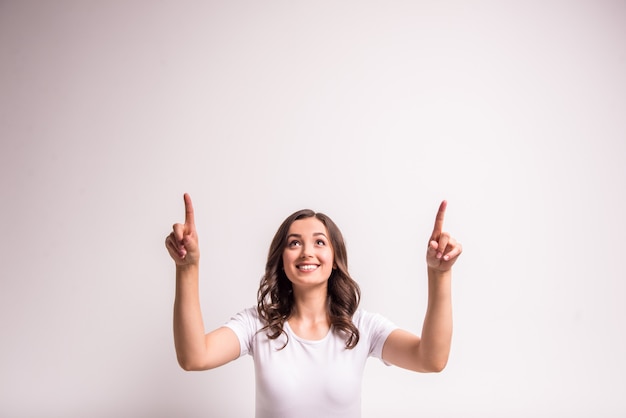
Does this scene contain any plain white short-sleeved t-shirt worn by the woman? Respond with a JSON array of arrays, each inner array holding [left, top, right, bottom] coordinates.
[[225, 308, 396, 418]]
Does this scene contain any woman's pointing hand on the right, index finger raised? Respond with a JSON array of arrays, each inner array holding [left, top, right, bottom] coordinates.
[[426, 200, 463, 272]]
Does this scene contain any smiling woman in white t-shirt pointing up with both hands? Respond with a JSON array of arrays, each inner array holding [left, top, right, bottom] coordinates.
[[166, 194, 462, 418]]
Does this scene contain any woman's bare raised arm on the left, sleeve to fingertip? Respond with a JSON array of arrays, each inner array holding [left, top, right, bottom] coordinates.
[[165, 194, 239, 370]]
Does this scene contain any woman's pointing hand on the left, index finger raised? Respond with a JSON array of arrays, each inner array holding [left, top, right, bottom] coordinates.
[[165, 193, 200, 266]]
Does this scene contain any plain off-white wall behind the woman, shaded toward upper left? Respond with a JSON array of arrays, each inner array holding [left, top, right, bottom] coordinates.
[[0, 0, 626, 417]]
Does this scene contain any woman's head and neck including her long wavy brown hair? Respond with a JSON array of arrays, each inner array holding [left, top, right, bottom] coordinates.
[[258, 209, 361, 348]]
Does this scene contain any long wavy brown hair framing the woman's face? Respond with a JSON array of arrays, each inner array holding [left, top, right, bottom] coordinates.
[[257, 209, 361, 349]]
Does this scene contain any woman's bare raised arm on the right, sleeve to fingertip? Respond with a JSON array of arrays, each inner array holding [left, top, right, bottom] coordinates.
[[383, 200, 462, 372]]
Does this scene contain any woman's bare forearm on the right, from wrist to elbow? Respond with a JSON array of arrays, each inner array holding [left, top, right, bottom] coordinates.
[[419, 268, 452, 371]]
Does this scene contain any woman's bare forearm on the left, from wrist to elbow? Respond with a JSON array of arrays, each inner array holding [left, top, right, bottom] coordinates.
[[174, 264, 206, 370]]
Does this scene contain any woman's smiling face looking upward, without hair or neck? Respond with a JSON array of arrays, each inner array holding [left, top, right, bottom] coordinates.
[[283, 217, 334, 288]]
